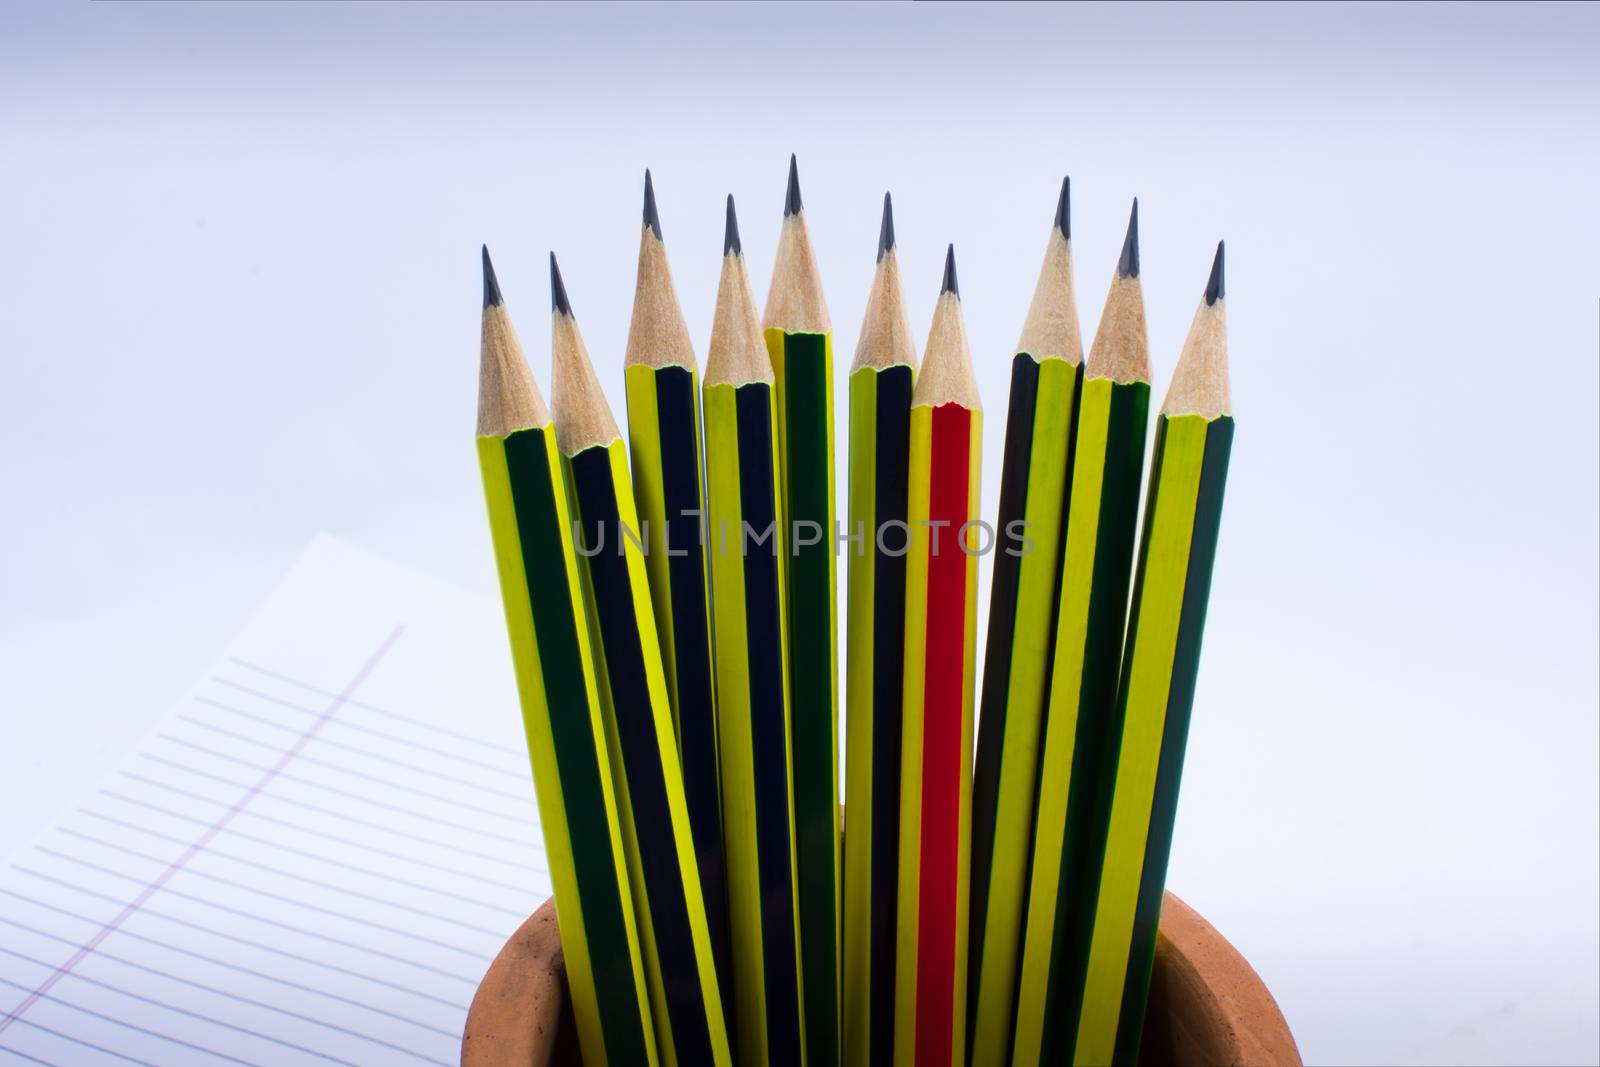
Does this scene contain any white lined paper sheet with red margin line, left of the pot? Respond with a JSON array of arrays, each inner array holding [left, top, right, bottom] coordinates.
[[0, 537, 550, 1065]]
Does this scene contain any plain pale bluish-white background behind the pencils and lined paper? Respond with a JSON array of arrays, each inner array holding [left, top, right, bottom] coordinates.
[[0, 5, 1600, 1062]]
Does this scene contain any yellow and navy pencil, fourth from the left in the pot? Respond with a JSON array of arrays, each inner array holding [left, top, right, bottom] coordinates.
[[704, 197, 805, 1064]]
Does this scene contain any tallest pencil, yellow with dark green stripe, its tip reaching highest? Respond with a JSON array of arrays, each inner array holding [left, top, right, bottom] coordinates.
[[762, 155, 840, 1065]]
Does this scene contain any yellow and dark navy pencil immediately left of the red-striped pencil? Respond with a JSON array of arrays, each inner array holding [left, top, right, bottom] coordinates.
[[843, 194, 917, 1067]]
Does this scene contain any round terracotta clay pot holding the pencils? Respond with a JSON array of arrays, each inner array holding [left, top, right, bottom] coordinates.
[[461, 893, 1301, 1067]]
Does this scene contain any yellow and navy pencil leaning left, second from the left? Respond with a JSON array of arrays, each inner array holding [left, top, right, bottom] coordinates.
[[550, 254, 731, 1064]]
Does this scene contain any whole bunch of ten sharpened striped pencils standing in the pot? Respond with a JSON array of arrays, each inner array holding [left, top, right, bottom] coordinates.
[[478, 168, 1234, 1067]]
